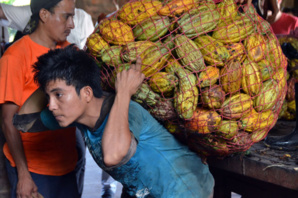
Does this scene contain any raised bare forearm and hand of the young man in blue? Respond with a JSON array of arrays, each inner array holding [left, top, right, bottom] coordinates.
[[102, 58, 145, 166]]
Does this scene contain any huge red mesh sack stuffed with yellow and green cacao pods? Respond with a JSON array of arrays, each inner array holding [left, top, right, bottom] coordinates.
[[87, 0, 287, 156]]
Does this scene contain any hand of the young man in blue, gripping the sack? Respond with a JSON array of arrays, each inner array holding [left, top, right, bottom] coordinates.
[[115, 57, 145, 96]]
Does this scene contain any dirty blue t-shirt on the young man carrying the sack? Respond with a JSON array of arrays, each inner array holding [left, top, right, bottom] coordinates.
[[43, 101, 214, 198]]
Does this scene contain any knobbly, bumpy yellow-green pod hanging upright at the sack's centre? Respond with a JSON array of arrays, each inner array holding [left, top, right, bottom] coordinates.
[[174, 64, 199, 119]]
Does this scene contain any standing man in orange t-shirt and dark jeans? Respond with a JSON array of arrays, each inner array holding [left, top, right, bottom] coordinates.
[[0, 0, 79, 198]]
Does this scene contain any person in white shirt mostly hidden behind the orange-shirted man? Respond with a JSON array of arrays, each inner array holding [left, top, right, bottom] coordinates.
[[0, 1, 117, 198]]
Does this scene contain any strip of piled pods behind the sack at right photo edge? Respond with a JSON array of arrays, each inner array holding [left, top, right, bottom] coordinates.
[[278, 35, 298, 120]]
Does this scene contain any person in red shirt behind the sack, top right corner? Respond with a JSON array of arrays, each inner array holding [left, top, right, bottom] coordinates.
[[258, 0, 298, 35]]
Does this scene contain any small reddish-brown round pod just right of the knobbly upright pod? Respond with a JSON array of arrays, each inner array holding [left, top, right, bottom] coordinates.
[[201, 85, 225, 109]]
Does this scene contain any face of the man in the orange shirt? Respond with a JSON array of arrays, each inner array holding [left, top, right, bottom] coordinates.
[[46, 0, 75, 42]]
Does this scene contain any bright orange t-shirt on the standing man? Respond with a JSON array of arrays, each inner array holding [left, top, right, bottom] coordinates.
[[0, 35, 78, 176]]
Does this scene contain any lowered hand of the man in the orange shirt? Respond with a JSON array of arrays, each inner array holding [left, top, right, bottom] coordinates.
[[16, 175, 40, 198]]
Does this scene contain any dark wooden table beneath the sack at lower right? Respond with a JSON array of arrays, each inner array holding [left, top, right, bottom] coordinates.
[[208, 121, 298, 198]]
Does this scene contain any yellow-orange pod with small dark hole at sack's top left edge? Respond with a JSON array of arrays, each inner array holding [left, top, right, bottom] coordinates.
[[118, 0, 162, 25]]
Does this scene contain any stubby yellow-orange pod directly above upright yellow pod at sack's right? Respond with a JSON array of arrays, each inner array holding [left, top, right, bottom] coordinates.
[[244, 33, 266, 62]]
